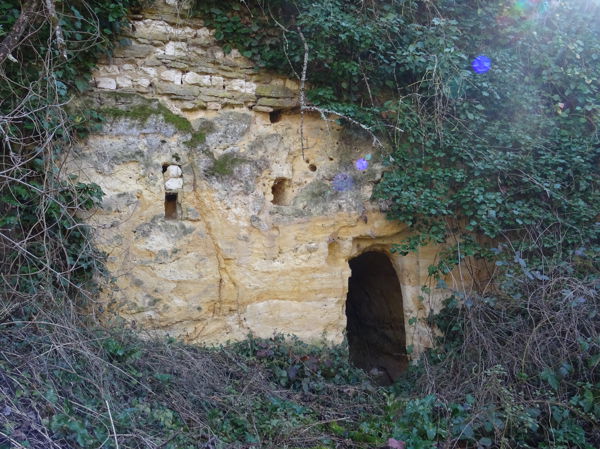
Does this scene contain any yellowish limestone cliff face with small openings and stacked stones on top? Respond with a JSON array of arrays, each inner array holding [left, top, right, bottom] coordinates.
[[69, 1, 448, 353]]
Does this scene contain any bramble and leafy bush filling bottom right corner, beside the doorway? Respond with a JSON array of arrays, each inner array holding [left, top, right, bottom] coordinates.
[[395, 250, 600, 449]]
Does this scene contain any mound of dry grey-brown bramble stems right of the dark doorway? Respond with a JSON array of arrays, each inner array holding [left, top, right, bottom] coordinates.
[[419, 252, 600, 447]]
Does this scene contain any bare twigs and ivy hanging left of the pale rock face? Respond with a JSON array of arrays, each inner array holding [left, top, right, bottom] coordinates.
[[0, 0, 142, 319]]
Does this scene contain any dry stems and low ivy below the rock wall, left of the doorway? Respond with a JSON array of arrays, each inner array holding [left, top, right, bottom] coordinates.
[[0, 321, 386, 449]]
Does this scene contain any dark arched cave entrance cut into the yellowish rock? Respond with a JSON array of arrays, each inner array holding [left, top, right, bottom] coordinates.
[[346, 251, 408, 384]]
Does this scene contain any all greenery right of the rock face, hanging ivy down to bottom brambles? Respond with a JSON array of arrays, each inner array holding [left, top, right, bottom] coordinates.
[[197, 0, 600, 448]]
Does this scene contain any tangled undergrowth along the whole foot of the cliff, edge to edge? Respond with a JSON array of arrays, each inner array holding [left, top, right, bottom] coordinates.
[[0, 256, 600, 449]]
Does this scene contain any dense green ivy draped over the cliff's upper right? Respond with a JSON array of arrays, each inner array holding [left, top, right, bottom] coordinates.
[[197, 0, 600, 268]]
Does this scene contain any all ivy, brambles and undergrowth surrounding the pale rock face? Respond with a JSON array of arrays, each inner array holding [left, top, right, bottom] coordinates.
[[0, 0, 600, 449]]
